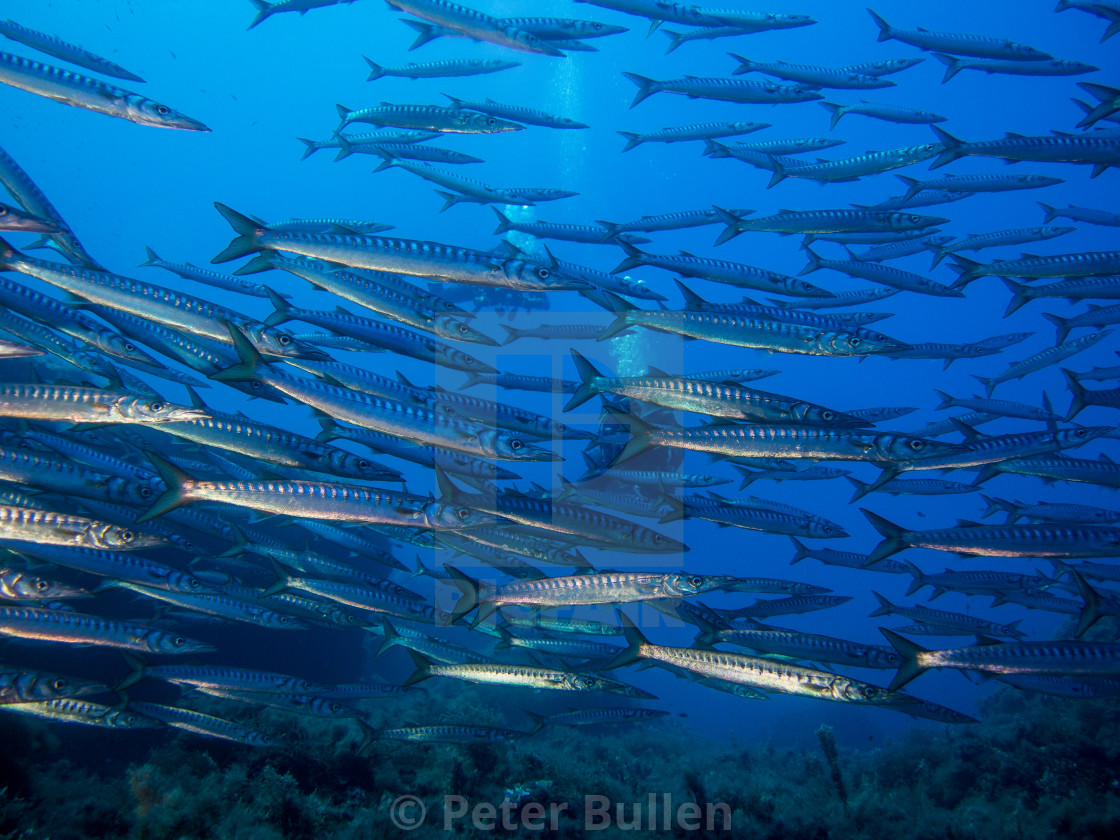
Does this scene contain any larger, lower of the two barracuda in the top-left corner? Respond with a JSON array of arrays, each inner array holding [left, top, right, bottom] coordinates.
[[0, 53, 209, 131]]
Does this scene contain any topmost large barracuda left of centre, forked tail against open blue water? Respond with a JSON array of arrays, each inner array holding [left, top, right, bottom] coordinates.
[[212, 203, 587, 291]]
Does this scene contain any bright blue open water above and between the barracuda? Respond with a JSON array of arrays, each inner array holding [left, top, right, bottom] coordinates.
[[0, 0, 1120, 801]]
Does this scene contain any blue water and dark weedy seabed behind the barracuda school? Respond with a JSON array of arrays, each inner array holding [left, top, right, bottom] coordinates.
[[0, 0, 1120, 839]]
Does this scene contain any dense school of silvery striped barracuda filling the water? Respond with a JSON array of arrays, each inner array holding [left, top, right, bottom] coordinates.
[[0, 0, 1120, 747]]
